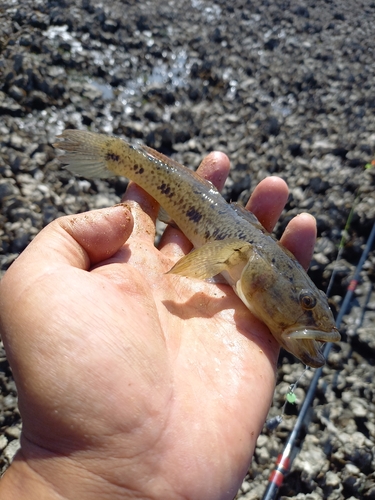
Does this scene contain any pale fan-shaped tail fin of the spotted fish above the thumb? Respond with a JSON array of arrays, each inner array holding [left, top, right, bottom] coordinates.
[[53, 130, 123, 179]]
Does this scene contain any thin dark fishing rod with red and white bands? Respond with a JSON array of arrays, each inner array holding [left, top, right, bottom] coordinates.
[[262, 222, 375, 500]]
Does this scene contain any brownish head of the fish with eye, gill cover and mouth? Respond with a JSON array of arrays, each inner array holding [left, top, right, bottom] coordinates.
[[236, 247, 340, 368]]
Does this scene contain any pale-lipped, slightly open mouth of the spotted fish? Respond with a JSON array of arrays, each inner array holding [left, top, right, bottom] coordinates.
[[282, 327, 341, 368]]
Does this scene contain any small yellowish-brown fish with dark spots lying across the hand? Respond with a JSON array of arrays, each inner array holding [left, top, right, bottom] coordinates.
[[54, 129, 340, 368]]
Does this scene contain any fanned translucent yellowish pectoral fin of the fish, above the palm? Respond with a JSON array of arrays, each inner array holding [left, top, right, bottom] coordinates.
[[168, 239, 252, 279]]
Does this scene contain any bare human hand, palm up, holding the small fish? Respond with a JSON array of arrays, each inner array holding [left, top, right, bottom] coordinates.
[[0, 153, 316, 500]]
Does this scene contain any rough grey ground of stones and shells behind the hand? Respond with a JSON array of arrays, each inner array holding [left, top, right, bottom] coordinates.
[[0, 0, 375, 500]]
